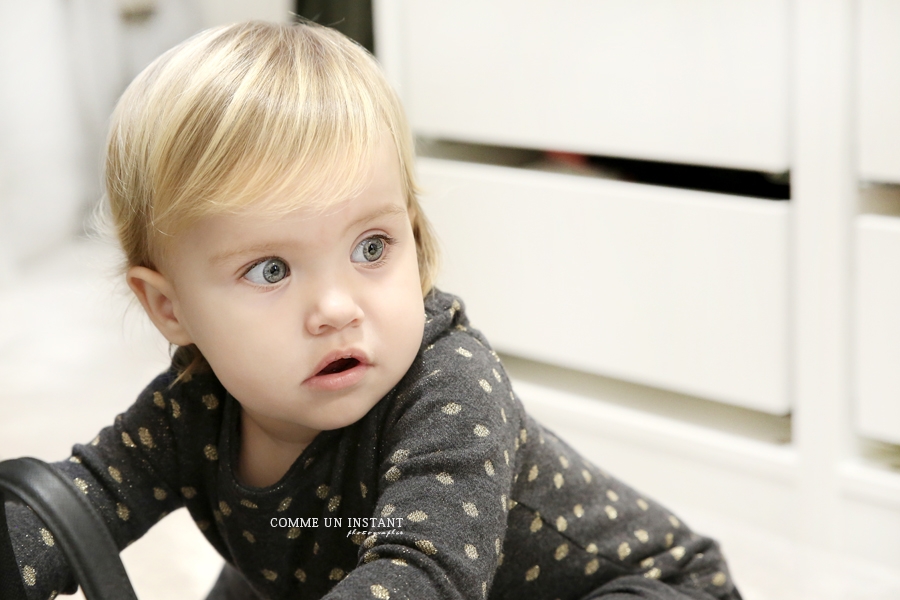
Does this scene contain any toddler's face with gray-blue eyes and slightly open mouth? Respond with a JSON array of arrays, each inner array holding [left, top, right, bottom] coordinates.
[[164, 139, 424, 442]]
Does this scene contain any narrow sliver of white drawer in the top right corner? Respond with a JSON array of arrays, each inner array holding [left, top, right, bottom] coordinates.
[[857, 0, 900, 182]]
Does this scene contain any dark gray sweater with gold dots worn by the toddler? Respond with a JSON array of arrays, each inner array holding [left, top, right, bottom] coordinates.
[[8, 292, 740, 600]]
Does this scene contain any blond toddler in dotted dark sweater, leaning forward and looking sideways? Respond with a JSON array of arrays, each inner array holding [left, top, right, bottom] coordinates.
[[8, 23, 740, 600]]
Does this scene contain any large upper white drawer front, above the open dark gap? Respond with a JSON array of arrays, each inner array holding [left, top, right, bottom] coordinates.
[[384, 0, 790, 171]]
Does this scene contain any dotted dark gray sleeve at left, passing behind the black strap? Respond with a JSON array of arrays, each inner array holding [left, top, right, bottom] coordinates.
[[6, 373, 188, 600]]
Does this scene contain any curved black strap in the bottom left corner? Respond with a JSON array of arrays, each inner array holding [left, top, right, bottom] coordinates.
[[0, 458, 137, 600]]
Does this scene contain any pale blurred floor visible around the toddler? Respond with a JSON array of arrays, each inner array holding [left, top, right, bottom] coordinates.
[[0, 239, 900, 600]]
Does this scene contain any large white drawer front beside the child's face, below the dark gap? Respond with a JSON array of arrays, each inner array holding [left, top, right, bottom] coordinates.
[[419, 159, 790, 414]]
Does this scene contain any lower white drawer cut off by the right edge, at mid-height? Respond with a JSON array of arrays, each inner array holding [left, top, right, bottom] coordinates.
[[854, 215, 900, 444]]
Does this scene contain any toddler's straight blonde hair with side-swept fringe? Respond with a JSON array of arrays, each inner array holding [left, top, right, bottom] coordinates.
[[106, 22, 438, 378]]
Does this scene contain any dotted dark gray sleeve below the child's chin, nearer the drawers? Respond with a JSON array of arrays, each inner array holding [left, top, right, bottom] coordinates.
[[326, 332, 519, 600]]
